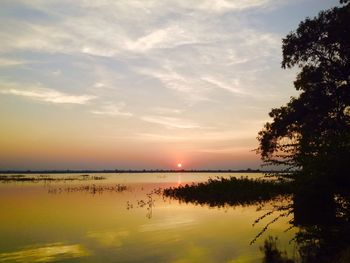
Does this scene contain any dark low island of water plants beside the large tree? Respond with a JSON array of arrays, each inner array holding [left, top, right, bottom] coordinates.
[[163, 177, 292, 206]]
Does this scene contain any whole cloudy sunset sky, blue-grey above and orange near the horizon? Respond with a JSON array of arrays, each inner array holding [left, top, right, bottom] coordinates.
[[0, 0, 338, 170]]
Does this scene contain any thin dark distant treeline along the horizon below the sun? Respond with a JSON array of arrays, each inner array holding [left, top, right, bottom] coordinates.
[[0, 168, 282, 174]]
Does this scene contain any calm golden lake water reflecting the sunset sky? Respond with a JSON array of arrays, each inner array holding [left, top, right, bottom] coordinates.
[[0, 173, 295, 262]]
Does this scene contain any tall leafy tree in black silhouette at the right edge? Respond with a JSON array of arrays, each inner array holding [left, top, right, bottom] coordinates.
[[258, 0, 350, 186]]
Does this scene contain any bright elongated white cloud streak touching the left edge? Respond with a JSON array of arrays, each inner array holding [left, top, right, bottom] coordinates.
[[0, 84, 96, 104]]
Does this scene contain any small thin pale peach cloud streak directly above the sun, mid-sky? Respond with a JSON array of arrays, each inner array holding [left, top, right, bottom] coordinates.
[[141, 116, 201, 129]]
